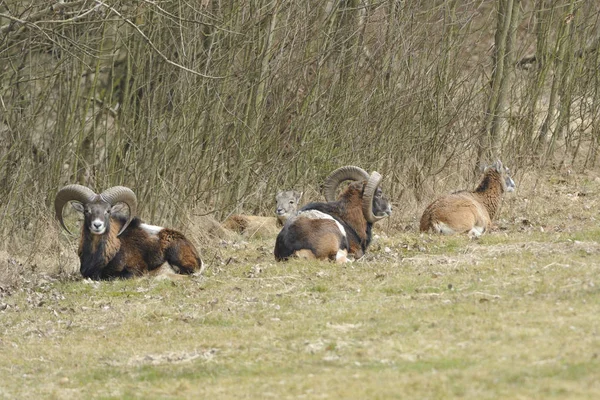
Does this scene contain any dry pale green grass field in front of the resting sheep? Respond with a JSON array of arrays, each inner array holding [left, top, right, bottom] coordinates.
[[0, 170, 600, 399]]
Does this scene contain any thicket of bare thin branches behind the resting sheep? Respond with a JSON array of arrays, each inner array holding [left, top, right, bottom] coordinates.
[[0, 0, 600, 247]]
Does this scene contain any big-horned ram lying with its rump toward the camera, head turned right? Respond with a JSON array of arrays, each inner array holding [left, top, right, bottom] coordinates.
[[274, 166, 392, 262]]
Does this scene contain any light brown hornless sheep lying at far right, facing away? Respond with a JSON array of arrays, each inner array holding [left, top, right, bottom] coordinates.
[[420, 161, 515, 237]]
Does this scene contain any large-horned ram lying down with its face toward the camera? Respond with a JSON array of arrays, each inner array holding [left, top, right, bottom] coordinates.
[[54, 185, 204, 280]]
